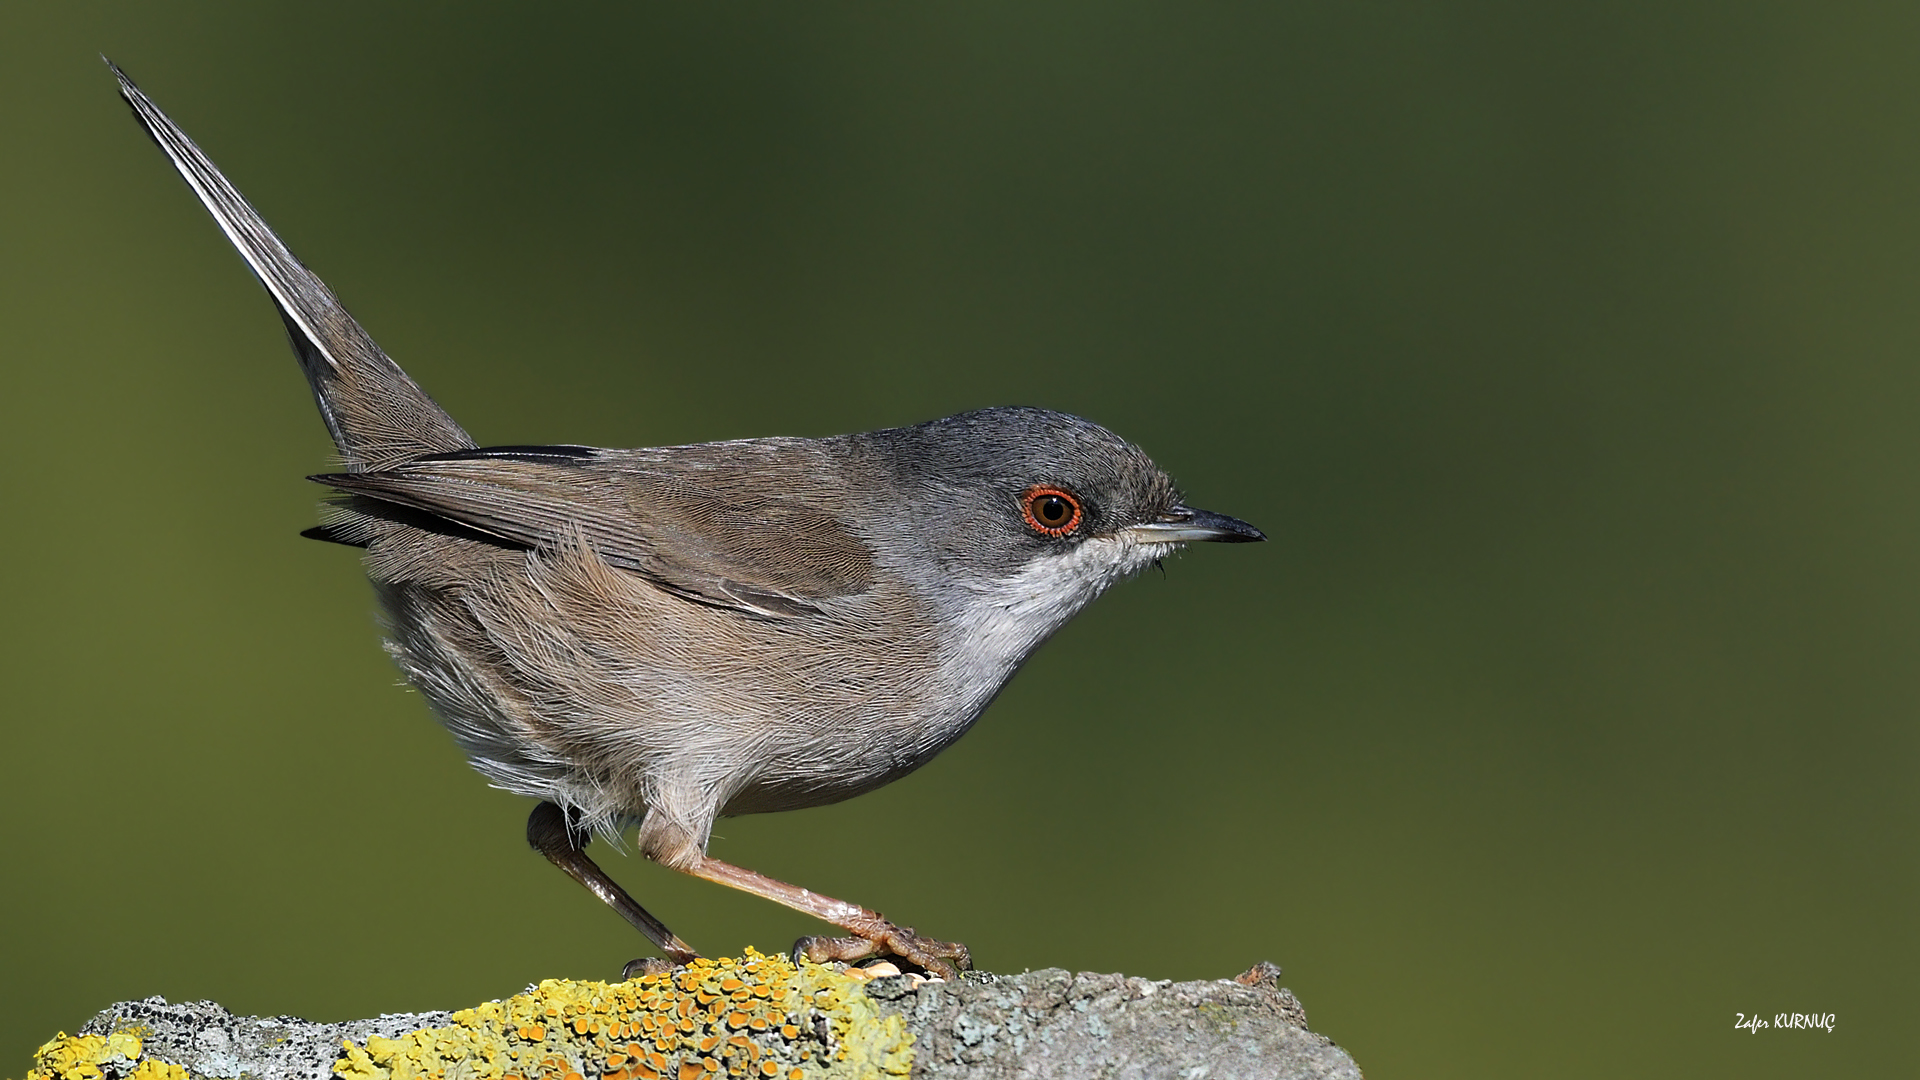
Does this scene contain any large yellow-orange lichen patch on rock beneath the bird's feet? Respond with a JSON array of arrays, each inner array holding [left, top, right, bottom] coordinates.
[[334, 949, 914, 1080]]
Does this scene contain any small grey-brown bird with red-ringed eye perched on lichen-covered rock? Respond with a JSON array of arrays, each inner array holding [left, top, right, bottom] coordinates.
[[108, 61, 1265, 976]]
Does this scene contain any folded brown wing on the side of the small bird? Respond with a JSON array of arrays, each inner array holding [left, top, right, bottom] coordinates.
[[311, 446, 874, 619]]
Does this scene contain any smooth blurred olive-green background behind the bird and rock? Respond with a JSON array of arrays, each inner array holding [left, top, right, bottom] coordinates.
[[0, 0, 1920, 1080]]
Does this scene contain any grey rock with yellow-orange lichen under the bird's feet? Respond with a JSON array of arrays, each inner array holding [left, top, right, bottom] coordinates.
[[29, 949, 1359, 1080]]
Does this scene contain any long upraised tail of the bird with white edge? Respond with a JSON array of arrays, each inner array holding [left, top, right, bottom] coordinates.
[[102, 58, 474, 473]]
